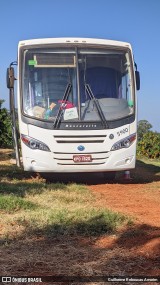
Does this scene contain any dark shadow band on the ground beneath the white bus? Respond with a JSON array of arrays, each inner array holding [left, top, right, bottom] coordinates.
[[0, 160, 160, 185]]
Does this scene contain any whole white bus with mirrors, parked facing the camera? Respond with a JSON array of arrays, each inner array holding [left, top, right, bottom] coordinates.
[[7, 38, 140, 178]]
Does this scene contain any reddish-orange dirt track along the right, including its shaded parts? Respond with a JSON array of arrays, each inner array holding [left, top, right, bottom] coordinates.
[[86, 163, 160, 276]]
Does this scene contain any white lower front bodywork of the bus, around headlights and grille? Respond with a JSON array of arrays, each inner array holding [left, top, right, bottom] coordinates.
[[22, 121, 136, 172]]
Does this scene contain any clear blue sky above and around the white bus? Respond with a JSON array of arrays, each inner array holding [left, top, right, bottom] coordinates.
[[0, 0, 160, 132]]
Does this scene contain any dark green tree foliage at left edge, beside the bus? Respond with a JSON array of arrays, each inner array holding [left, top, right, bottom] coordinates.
[[0, 100, 12, 148]]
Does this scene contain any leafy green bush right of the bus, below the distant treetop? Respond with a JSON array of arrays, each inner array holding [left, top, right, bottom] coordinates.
[[137, 131, 160, 159]]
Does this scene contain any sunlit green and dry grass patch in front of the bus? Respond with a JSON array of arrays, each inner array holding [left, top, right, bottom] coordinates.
[[0, 149, 130, 240]]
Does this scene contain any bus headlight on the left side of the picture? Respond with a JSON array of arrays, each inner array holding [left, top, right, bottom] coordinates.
[[21, 134, 50, 151]]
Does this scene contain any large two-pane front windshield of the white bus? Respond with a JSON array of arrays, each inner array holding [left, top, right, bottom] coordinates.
[[22, 48, 135, 124]]
